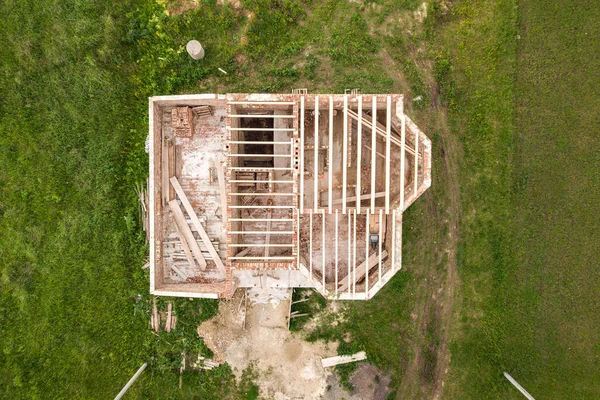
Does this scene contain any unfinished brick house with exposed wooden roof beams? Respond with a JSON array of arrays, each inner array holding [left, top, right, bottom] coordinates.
[[149, 91, 431, 300]]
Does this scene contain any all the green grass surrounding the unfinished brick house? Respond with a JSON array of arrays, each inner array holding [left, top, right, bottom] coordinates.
[[0, 0, 600, 399]]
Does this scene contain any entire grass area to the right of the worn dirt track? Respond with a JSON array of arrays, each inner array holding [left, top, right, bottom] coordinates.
[[445, 0, 600, 399]]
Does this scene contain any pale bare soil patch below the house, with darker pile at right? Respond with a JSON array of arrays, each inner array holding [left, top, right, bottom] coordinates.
[[198, 290, 389, 400]]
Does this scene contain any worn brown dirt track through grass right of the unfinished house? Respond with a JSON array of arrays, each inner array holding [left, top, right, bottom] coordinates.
[[398, 84, 461, 399]]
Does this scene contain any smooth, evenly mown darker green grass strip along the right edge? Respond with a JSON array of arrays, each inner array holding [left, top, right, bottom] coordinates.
[[503, 0, 600, 399]]
